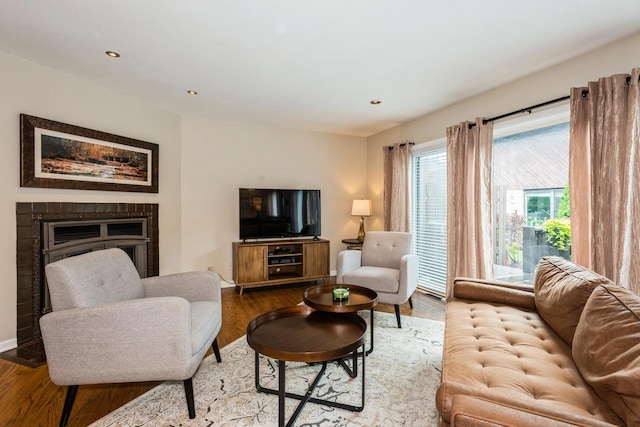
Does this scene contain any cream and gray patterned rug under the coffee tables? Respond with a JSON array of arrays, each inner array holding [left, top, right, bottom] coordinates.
[[91, 311, 444, 427]]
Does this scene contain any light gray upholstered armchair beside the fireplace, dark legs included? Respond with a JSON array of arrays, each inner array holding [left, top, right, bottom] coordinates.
[[40, 249, 222, 426]]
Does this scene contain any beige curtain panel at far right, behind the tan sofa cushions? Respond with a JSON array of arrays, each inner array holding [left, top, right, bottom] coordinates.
[[569, 68, 640, 292]]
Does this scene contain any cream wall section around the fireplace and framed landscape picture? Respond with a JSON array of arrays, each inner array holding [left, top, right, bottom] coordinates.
[[0, 52, 181, 349]]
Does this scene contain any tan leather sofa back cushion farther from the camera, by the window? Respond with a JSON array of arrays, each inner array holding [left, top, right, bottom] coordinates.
[[534, 256, 613, 345]]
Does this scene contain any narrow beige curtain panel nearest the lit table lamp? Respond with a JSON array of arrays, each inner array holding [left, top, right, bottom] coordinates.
[[382, 142, 413, 231]]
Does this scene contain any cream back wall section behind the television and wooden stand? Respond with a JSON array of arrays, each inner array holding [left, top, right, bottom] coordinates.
[[182, 118, 367, 280]]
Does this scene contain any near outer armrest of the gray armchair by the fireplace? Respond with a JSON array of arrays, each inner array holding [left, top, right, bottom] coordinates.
[[40, 297, 192, 385]]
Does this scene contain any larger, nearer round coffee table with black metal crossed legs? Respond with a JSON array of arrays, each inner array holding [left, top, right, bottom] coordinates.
[[247, 305, 367, 426]]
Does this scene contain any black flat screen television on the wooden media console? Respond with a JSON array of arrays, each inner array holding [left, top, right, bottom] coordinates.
[[240, 188, 321, 240]]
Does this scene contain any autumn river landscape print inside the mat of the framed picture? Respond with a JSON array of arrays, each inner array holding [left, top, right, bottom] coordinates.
[[36, 129, 151, 185]]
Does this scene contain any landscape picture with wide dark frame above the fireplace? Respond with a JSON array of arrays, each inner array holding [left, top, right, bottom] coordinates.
[[20, 114, 159, 193]]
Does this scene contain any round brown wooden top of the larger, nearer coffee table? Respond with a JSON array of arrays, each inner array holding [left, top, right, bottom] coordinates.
[[247, 305, 367, 363]]
